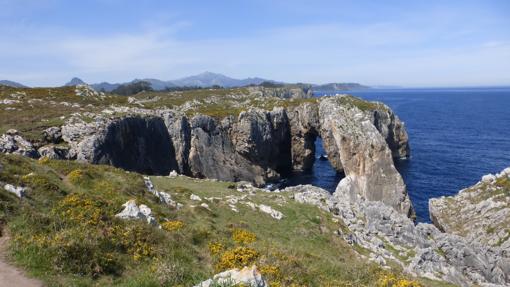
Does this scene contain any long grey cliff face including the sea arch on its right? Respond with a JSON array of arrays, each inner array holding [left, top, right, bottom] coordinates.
[[56, 96, 410, 201]]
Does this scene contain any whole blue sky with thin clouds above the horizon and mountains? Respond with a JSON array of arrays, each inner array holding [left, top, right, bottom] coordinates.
[[0, 0, 510, 87]]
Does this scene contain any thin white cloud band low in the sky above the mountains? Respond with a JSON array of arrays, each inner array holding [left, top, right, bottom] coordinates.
[[0, 18, 510, 85]]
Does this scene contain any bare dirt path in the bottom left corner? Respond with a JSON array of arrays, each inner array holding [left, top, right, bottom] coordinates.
[[0, 230, 43, 287]]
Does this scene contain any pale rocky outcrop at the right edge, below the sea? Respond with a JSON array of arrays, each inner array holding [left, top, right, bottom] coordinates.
[[429, 168, 510, 251]]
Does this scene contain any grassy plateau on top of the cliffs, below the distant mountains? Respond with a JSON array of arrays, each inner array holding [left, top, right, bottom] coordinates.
[[0, 85, 384, 142]]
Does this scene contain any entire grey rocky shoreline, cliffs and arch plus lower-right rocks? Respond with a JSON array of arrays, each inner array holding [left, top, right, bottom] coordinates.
[[0, 84, 510, 286]]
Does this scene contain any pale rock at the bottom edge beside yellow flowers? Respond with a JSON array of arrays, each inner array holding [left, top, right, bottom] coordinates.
[[194, 265, 268, 287]]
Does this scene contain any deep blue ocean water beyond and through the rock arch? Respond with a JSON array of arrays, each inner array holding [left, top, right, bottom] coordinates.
[[291, 88, 510, 222]]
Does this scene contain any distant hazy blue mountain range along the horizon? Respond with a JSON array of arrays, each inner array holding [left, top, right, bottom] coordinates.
[[0, 72, 368, 92]]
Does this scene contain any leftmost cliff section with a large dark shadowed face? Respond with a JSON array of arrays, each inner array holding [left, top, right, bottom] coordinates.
[[62, 116, 178, 175]]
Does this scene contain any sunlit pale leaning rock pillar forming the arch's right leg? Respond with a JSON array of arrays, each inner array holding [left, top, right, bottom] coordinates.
[[319, 97, 414, 216]]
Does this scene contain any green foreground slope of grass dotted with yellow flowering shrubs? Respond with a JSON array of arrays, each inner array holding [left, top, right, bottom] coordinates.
[[0, 155, 452, 286]]
